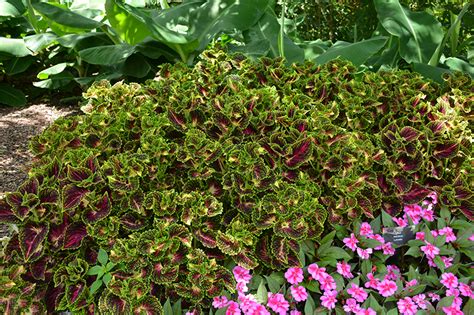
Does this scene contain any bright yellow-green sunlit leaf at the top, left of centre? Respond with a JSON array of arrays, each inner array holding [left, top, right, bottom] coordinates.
[[105, 0, 151, 45]]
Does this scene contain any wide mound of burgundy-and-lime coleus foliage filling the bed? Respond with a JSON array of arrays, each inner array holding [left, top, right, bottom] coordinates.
[[0, 51, 474, 314]]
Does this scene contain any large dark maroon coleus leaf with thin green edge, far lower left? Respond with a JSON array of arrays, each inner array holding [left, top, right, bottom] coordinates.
[[19, 222, 49, 262]]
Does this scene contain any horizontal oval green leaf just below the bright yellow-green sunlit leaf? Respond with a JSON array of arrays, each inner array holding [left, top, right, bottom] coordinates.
[[79, 44, 135, 65]]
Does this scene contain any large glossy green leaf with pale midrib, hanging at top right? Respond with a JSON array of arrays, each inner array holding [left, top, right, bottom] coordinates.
[[374, 0, 443, 63]]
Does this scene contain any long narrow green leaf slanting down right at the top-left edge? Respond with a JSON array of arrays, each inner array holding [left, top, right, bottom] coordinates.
[[33, 2, 102, 30]]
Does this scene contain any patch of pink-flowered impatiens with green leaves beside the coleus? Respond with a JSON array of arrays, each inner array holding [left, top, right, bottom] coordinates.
[[212, 195, 474, 315]]
